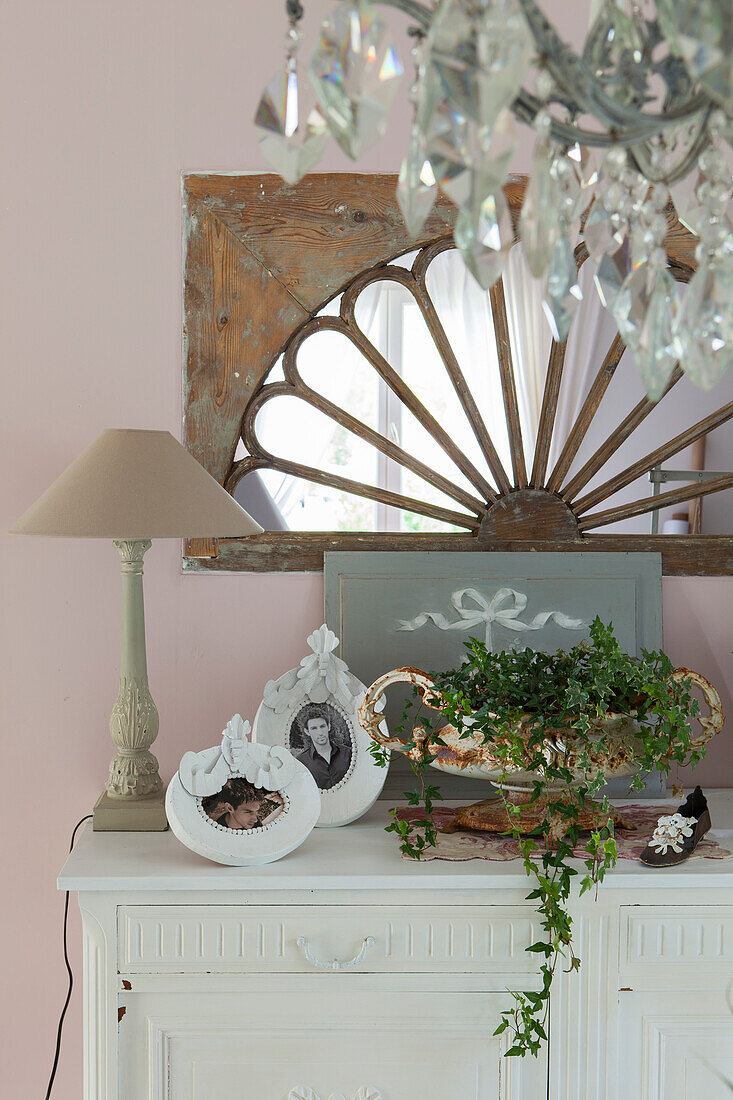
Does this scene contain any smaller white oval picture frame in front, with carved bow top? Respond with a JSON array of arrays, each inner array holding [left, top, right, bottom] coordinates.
[[165, 714, 320, 867]]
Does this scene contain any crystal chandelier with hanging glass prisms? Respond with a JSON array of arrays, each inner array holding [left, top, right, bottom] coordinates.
[[255, 0, 733, 400]]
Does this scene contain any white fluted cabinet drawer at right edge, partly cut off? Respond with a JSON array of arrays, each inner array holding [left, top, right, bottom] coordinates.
[[620, 905, 733, 985]]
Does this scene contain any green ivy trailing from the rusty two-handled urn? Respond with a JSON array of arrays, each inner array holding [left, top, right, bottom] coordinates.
[[372, 617, 704, 1057]]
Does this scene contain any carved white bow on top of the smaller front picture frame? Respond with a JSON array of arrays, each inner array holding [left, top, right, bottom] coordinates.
[[178, 714, 295, 799]]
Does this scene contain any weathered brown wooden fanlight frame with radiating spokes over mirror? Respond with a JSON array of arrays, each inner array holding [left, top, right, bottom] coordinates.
[[185, 174, 733, 574]]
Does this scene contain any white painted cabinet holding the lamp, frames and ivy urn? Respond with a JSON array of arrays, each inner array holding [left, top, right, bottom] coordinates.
[[59, 795, 733, 1100]]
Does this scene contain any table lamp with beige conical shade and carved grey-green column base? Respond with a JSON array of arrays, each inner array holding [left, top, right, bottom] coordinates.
[[11, 428, 262, 832]]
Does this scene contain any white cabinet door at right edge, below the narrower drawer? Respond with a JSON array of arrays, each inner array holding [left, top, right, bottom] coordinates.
[[619, 990, 733, 1100]]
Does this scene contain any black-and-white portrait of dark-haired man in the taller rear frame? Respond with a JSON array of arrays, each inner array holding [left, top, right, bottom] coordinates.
[[288, 703, 353, 791]]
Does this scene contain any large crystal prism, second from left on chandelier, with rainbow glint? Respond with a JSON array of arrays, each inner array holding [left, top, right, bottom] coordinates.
[[310, 0, 402, 160]]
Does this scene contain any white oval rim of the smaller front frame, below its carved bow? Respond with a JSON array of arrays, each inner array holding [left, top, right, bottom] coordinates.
[[165, 719, 320, 867]]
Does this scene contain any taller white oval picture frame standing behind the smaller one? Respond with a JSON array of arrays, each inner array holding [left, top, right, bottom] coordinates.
[[252, 624, 387, 828]]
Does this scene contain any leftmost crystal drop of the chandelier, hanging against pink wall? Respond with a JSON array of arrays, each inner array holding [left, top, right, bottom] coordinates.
[[254, 57, 328, 184]]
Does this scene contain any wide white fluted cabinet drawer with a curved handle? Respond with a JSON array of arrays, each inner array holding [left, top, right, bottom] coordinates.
[[118, 905, 540, 975]]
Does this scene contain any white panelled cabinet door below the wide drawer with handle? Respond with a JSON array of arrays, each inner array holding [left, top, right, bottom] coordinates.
[[120, 979, 547, 1100]]
